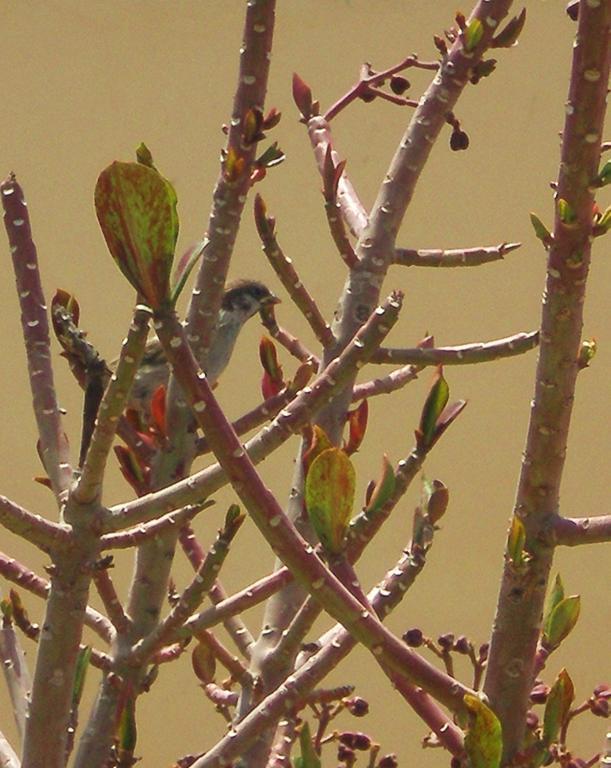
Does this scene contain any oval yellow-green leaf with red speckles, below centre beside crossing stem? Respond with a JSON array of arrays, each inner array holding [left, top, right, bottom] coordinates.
[[305, 448, 355, 554]]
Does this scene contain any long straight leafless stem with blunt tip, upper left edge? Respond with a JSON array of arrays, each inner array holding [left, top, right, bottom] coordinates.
[[0, 174, 72, 504]]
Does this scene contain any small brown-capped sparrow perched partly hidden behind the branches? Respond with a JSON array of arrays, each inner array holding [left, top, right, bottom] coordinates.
[[130, 279, 280, 413]]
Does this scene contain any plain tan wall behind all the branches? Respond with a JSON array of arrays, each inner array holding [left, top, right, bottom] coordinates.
[[0, 0, 611, 766]]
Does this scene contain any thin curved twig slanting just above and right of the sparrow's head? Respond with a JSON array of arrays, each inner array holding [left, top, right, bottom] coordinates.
[[255, 195, 333, 348]]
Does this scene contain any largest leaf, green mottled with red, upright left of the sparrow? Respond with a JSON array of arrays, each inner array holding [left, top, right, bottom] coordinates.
[[95, 162, 178, 309]]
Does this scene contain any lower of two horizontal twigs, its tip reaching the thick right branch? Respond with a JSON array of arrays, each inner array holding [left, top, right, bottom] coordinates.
[[372, 331, 539, 366]]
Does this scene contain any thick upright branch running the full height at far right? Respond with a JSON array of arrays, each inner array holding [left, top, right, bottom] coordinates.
[[484, 2, 611, 762]]
